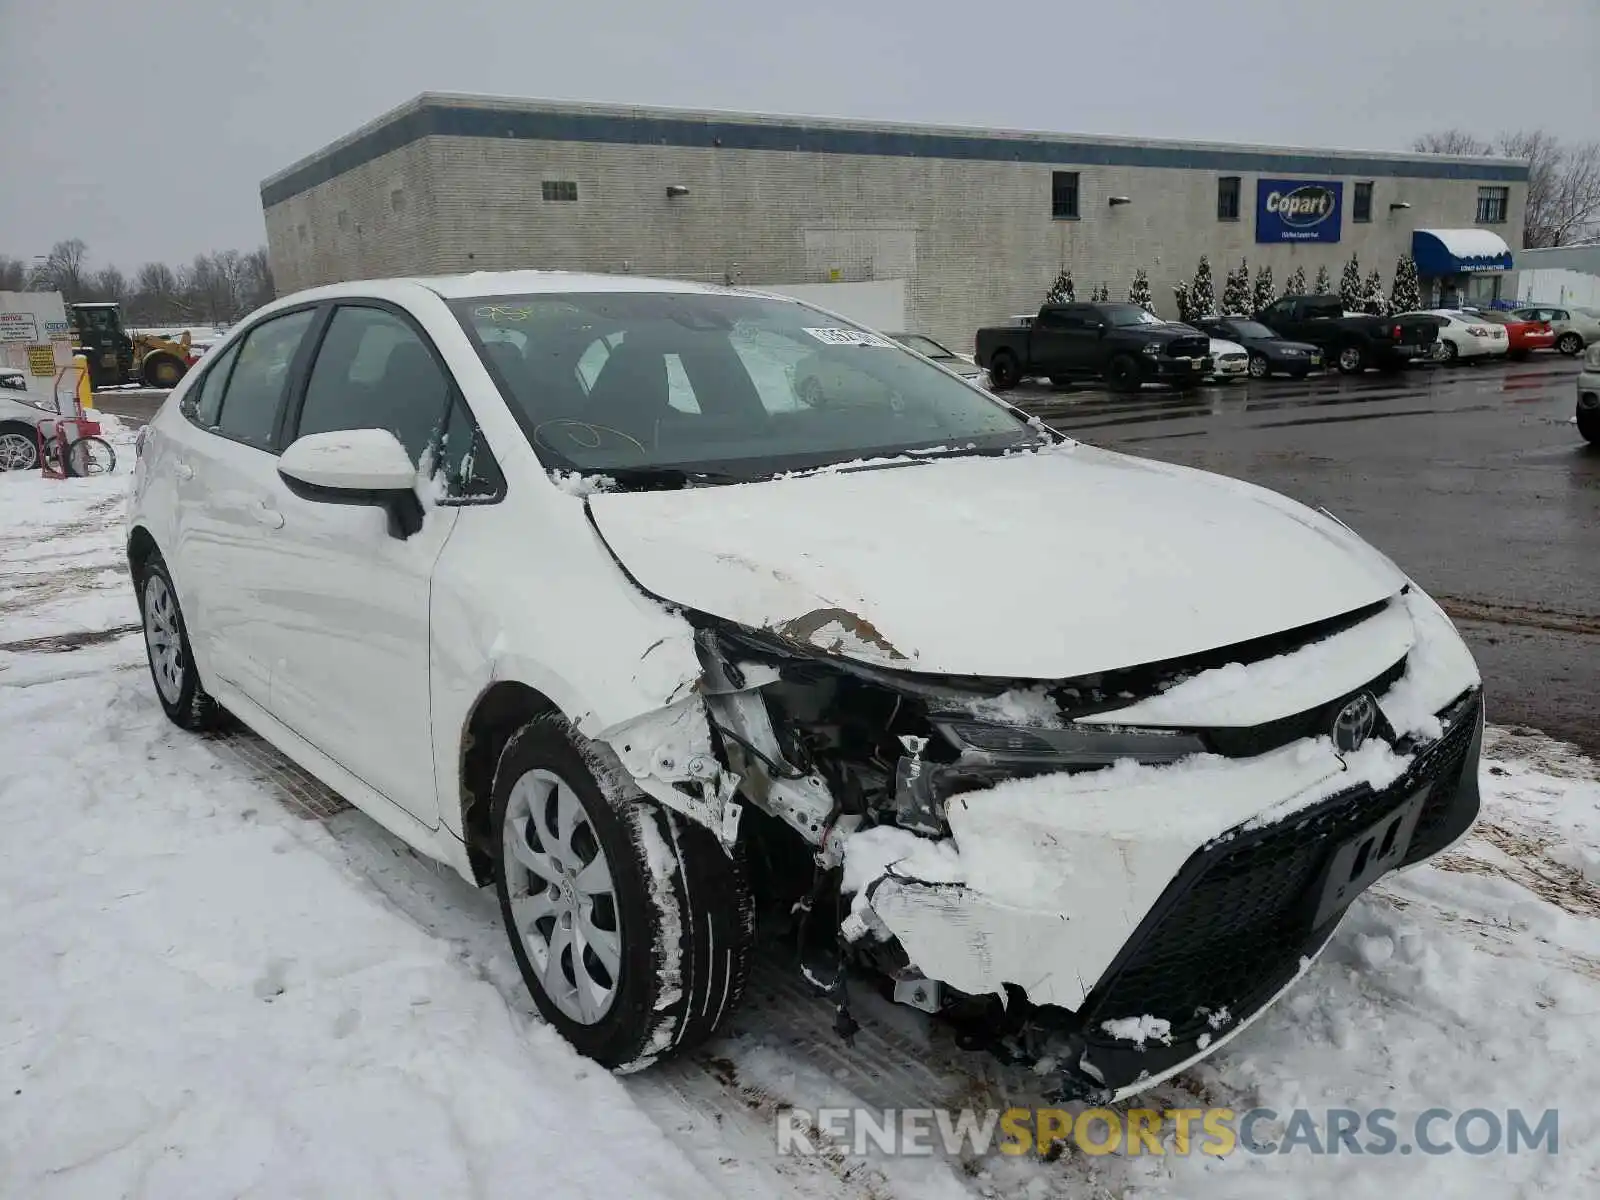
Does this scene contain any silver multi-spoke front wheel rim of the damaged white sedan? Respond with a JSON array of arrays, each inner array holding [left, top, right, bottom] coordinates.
[[501, 770, 622, 1026]]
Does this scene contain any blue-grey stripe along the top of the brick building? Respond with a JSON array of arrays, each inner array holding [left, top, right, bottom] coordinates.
[[261, 106, 1528, 208]]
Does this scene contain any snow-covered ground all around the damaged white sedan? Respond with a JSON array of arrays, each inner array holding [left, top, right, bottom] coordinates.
[[0, 437, 1600, 1200]]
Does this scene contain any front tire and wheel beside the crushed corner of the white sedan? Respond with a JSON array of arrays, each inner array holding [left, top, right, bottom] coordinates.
[[491, 714, 755, 1070]]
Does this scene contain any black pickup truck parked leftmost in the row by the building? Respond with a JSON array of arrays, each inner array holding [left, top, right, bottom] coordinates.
[[974, 304, 1211, 390]]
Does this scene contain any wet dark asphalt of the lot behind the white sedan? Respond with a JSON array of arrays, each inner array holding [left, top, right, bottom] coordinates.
[[98, 355, 1600, 754]]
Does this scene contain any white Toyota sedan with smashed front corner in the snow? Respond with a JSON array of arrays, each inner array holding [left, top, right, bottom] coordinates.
[[128, 272, 1483, 1096]]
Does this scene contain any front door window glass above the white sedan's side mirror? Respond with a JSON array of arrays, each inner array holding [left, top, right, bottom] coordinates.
[[294, 306, 450, 462]]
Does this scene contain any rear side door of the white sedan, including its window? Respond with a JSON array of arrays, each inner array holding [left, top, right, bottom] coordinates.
[[171, 307, 315, 707]]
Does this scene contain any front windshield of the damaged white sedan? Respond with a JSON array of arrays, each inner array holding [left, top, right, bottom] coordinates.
[[451, 291, 1050, 483]]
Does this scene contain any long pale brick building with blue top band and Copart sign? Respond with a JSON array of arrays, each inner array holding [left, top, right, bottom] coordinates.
[[261, 94, 1528, 349]]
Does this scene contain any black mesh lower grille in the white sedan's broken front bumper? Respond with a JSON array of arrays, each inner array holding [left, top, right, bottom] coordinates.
[[1082, 693, 1480, 1086]]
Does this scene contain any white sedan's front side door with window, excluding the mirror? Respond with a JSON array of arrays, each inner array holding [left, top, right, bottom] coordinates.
[[256, 302, 459, 827]]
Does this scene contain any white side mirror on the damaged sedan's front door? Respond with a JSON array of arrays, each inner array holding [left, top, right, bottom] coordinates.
[[278, 429, 422, 541]]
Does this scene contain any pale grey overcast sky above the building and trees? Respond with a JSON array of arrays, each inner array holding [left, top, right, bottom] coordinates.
[[0, 0, 1600, 269]]
